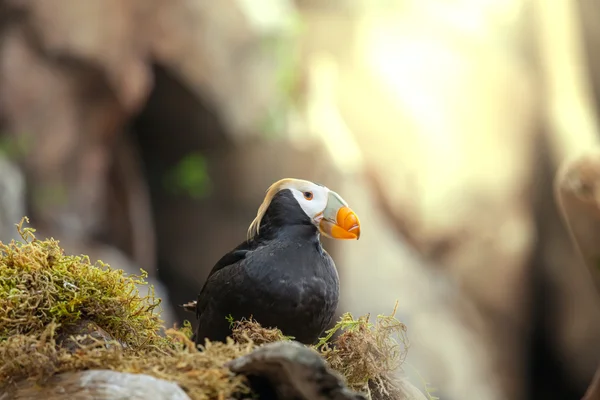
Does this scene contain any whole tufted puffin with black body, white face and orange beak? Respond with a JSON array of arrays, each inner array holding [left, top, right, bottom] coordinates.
[[194, 178, 360, 345]]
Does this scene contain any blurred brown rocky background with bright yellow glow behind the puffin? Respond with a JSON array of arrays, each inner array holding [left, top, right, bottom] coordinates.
[[0, 0, 600, 400]]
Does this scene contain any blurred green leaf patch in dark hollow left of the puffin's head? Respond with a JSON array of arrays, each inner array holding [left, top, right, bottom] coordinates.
[[164, 152, 212, 199]]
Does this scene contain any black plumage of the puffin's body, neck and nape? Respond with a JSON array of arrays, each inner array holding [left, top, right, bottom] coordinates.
[[195, 189, 339, 344]]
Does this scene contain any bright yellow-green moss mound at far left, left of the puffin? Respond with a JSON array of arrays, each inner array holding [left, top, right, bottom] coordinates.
[[0, 219, 163, 348]]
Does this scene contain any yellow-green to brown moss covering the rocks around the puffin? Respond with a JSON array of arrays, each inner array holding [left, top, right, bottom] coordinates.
[[0, 218, 407, 400]]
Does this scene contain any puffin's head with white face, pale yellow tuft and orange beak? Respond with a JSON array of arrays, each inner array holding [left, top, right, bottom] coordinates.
[[248, 178, 360, 239]]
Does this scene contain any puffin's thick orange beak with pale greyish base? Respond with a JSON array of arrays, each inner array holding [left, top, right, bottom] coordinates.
[[319, 192, 360, 240]]
